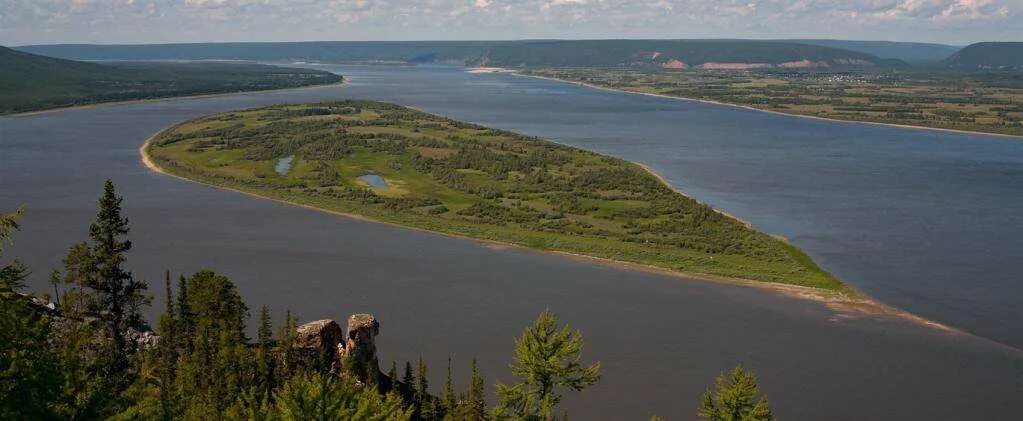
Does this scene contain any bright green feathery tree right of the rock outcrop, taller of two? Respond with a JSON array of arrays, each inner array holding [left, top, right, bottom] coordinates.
[[496, 310, 601, 420]]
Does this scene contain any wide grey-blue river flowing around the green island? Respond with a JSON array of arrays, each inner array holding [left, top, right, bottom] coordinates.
[[0, 66, 1023, 419]]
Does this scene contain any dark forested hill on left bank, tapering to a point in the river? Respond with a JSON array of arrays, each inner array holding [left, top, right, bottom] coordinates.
[[0, 47, 341, 114]]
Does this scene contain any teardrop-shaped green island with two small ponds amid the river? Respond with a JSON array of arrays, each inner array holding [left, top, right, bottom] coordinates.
[[143, 101, 851, 292]]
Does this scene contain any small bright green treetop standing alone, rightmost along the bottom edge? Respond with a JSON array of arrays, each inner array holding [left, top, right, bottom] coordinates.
[[698, 365, 774, 421]]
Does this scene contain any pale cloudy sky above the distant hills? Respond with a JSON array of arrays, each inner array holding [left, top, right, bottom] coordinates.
[[0, 0, 1023, 45]]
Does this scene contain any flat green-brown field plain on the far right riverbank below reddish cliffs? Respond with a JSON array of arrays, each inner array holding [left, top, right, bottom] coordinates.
[[524, 67, 1023, 136]]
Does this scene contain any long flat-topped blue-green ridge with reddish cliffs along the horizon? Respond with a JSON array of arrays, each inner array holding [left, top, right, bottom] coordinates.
[[12, 40, 901, 67]]
